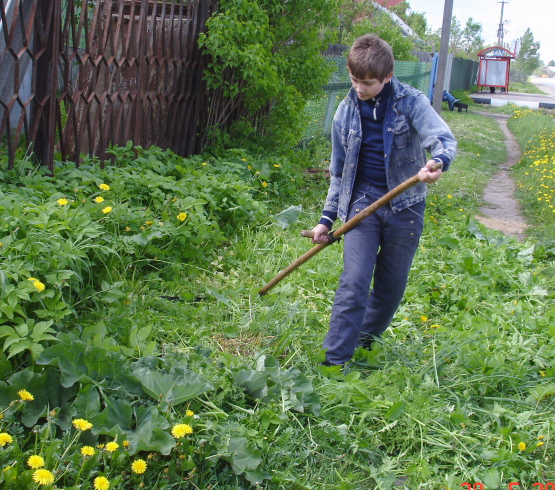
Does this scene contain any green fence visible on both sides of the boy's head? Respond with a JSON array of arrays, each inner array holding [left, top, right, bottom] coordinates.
[[304, 55, 432, 139]]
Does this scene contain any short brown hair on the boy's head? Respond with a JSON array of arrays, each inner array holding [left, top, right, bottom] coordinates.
[[347, 34, 395, 82]]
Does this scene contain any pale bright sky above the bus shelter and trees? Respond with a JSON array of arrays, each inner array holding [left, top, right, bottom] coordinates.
[[408, 0, 555, 64]]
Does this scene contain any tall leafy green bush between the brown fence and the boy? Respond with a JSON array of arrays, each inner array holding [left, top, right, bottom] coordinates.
[[199, 0, 335, 148]]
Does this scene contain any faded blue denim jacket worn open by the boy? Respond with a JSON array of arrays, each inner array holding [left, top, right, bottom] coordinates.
[[324, 77, 457, 221]]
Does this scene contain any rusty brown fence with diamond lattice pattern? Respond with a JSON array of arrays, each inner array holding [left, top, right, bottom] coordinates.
[[0, 0, 217, 171]]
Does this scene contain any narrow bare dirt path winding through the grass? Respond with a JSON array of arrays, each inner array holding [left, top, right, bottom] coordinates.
[[477, 112, 528, 241]]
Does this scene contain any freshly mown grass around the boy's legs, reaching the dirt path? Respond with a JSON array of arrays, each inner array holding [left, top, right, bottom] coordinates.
[[153, 113, 555, 490]]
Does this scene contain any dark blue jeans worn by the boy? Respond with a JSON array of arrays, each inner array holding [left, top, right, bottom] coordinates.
[[323, 184, 426, 364]]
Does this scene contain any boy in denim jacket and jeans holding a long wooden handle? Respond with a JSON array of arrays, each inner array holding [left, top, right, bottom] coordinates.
[[313, 34, 457, 365]]
